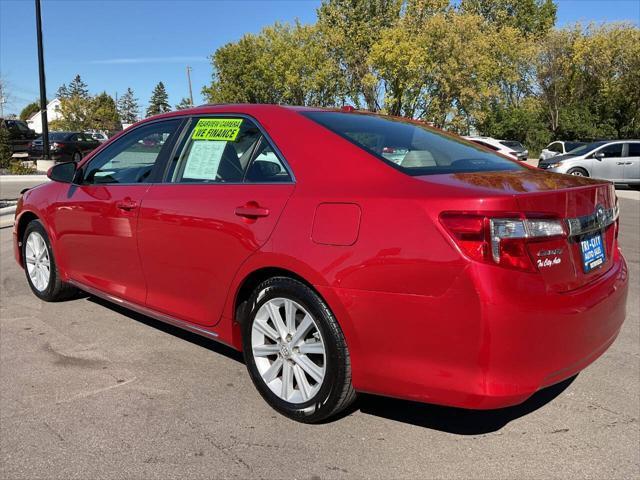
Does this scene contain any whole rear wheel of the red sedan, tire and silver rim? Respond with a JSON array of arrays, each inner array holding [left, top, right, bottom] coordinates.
[[243, 277, 356, 423]]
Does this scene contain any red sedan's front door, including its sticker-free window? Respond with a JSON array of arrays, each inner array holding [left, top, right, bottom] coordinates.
[[53, 119, 182, 305]]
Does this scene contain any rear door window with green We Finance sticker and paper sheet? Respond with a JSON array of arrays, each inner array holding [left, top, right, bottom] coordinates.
[[168, 117, 262, 183]]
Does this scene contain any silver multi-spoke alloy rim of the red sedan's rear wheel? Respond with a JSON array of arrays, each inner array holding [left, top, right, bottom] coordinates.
[[251, 298, 326, 403]]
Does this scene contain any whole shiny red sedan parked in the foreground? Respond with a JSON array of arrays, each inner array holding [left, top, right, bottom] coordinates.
[[14, 105, 628, 422]]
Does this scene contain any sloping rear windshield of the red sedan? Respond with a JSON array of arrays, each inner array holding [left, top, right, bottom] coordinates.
[[302, 111, 524, 176]]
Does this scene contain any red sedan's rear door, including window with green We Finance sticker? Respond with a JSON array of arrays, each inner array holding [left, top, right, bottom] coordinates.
[[138, 115, 294, 326]]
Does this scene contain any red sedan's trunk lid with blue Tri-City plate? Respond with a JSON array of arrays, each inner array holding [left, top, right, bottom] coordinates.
[[417, 169, 617, 292]]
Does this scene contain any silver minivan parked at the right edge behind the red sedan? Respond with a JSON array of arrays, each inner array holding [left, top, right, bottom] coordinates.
[[538, 140, 640, 185]]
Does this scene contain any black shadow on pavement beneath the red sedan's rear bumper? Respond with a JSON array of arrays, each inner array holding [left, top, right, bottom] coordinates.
[[354, 375, 577, 435]]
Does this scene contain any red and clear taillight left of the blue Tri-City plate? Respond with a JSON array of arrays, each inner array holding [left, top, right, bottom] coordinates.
[[440, 212, 565, 272]]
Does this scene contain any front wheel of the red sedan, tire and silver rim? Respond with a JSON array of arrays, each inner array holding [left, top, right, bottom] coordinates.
[[22, 220, 76, 302]]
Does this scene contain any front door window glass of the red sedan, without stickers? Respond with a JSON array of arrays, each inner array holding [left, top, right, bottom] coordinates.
[[83, 119, 182, 184]]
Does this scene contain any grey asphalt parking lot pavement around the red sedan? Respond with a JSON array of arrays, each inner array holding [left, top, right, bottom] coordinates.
[[0, 192, 640, 480]]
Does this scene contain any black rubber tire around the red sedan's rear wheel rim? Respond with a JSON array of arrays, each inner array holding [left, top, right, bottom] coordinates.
[[241, 277, 356, 423]]
